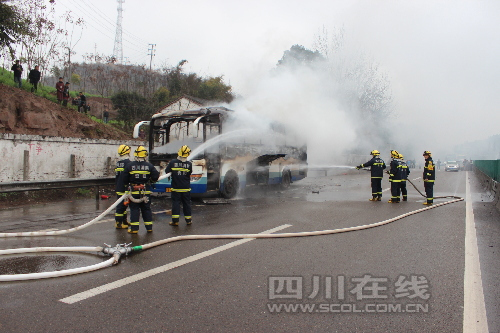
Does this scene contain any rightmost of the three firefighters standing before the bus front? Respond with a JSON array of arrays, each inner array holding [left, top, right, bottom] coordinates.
[[165, 145, 193, 226]]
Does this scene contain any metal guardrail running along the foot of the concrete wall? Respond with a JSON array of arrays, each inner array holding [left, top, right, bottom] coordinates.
[[0, 177, 115, 193]]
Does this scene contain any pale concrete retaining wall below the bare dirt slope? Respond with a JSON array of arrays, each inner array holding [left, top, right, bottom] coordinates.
[[0, 134, 139, 182]]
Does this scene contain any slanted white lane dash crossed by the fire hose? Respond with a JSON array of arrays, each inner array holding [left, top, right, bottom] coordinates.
[[59, 224, 291, 304]]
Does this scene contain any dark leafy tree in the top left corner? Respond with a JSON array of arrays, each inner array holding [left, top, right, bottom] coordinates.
[[0, 0, 31, 59]]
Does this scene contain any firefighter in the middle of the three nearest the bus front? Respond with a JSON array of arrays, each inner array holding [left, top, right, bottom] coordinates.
[[120, 146, 160, 234]]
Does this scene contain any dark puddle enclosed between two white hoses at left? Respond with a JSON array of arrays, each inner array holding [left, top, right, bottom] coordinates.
[[0, 253, 103, 275]]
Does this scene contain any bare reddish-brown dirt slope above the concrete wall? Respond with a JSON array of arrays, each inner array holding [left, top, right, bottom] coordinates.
[[0, 84, 132, 140]]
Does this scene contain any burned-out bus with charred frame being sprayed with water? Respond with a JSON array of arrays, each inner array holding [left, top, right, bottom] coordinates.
[[134, 107, 307, 198]]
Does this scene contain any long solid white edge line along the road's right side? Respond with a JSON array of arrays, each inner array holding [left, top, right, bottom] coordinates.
[[463, 172, 488, 333]]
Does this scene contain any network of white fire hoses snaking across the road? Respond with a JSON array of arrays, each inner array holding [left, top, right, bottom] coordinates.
[[0, 175, 464, 282]]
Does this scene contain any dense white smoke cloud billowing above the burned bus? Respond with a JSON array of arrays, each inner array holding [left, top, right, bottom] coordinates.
[[230, 48, 389, 165]]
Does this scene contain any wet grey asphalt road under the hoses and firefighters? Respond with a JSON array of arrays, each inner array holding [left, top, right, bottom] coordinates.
[[0, 170, 499, 332]]
